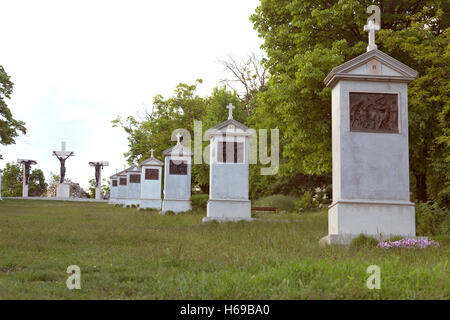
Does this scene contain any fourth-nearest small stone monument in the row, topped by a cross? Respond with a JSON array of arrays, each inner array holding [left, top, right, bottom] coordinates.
[[140, 149, 164, 209]]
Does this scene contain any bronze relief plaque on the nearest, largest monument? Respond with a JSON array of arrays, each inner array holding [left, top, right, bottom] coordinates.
[[350, 92, 398, 133]]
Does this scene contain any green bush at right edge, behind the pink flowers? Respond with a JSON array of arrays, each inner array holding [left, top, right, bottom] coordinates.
[[416, 202, 450, 236]]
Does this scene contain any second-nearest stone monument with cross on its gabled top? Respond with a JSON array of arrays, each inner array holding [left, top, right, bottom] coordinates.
[[203, 103, 253, 222]]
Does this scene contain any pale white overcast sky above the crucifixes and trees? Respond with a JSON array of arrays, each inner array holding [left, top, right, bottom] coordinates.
[[0, 0, 262, 187]]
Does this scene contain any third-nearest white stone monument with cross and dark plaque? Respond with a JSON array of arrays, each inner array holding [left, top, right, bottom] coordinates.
[[162, 134, 192, 212]]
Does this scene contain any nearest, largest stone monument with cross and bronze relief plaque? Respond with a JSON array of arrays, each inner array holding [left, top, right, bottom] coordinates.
[[321, 14, 417, 244]]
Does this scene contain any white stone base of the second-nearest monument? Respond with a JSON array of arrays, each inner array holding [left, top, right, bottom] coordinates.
[[203, 200, 252, 222]]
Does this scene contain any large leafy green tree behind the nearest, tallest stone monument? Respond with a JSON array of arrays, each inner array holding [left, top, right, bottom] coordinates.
[[251, 0, 450, 201]]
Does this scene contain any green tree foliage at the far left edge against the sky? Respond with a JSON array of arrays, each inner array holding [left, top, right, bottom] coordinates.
[[0, 65, 26, 159]]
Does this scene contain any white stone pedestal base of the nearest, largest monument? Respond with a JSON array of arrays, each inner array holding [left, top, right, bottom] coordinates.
[[320, 200, 416, 245]]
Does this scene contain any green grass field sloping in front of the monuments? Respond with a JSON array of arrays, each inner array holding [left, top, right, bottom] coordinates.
[[0, 200, 450, 299]]
